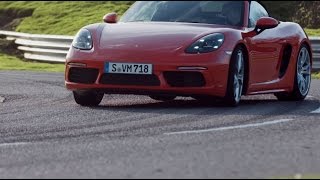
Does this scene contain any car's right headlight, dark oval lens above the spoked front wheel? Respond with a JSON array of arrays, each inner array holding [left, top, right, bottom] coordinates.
[[186, 33, 224, 54]]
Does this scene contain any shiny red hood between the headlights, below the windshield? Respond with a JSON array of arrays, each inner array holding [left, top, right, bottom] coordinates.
[[99, 22, 238, 52]]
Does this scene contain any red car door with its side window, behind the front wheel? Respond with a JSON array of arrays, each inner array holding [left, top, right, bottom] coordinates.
[[246, 1, 282, 91]]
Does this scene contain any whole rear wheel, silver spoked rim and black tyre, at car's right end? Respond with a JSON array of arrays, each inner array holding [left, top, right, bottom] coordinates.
[[275, 45, 311, 101]]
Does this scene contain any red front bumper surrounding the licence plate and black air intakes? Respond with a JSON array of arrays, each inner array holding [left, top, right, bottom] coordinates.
[[65, 46, 231, 97]]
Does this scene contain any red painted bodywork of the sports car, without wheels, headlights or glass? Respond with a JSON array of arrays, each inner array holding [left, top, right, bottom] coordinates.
[[65, 1, 311, 97]]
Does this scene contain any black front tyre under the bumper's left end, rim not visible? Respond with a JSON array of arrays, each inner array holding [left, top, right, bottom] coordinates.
[[73, 91, 104, 107]]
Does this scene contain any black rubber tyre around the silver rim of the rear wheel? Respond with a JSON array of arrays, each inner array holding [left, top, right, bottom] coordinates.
[[274, 45, 311, 101]]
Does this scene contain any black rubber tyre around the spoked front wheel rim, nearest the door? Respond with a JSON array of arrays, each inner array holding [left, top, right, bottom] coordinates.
[[224, 46, 246, 107]]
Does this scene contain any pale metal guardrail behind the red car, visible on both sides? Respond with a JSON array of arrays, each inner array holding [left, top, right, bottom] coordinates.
[[0, 31, 320, 70]]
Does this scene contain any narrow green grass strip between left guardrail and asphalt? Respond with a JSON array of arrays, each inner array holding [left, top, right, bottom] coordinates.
[[0, 54, 65, 72]]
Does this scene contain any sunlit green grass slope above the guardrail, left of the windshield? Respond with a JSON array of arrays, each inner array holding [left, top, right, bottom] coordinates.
[[0, 1, 133, 35]]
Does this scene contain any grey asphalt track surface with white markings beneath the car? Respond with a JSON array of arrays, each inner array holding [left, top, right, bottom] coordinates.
[[0, 71, 320, 178]]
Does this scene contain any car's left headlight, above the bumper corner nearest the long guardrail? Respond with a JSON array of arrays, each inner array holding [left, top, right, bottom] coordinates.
[[72, 29, 92, 50]]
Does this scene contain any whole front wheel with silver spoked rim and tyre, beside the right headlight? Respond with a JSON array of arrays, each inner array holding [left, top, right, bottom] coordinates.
[[224, 46, 245, 106]]
